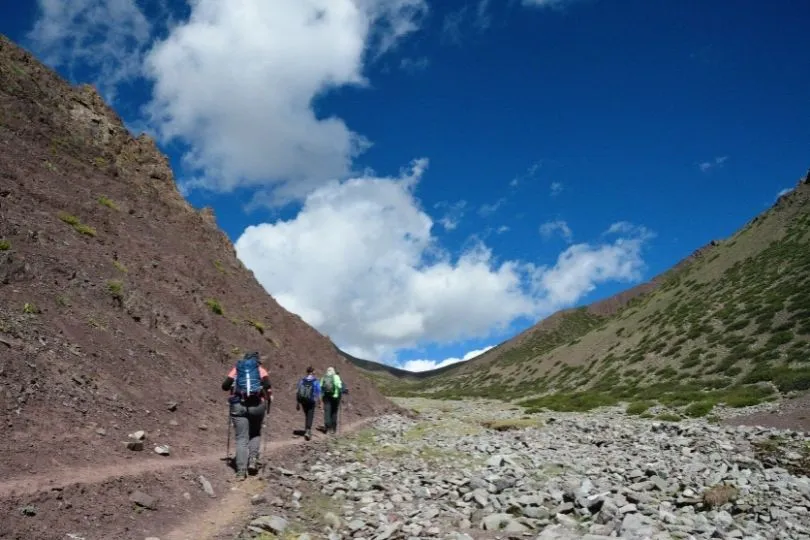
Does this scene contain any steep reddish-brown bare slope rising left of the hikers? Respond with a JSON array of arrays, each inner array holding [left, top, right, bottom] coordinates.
[[0, 36, 393, 486]]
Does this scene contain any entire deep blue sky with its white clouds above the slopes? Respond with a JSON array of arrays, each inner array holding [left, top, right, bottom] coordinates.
[[0, 0, 810, 369]]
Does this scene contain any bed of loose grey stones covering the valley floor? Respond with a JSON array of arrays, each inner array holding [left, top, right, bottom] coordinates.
[[223, 398, 810, 540]]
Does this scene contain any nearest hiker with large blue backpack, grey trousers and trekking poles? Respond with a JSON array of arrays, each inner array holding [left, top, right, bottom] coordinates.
[[222, 352, 273, 480]]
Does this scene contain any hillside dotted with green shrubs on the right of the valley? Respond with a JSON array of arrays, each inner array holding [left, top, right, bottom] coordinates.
[[350, 172, 810, 409]]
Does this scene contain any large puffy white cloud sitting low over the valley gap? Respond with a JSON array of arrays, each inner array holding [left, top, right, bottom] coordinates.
[[236, 160, 646, 361]]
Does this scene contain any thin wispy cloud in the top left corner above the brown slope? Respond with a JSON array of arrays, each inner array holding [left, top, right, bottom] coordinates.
[[26, 0, 153, 102]]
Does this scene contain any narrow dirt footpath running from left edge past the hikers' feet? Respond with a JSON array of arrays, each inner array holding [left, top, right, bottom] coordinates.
[[0, 418, 373, 499]]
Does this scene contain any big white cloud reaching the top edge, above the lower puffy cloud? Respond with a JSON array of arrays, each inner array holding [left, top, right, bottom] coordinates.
[[145, 0, 427, 204]]
